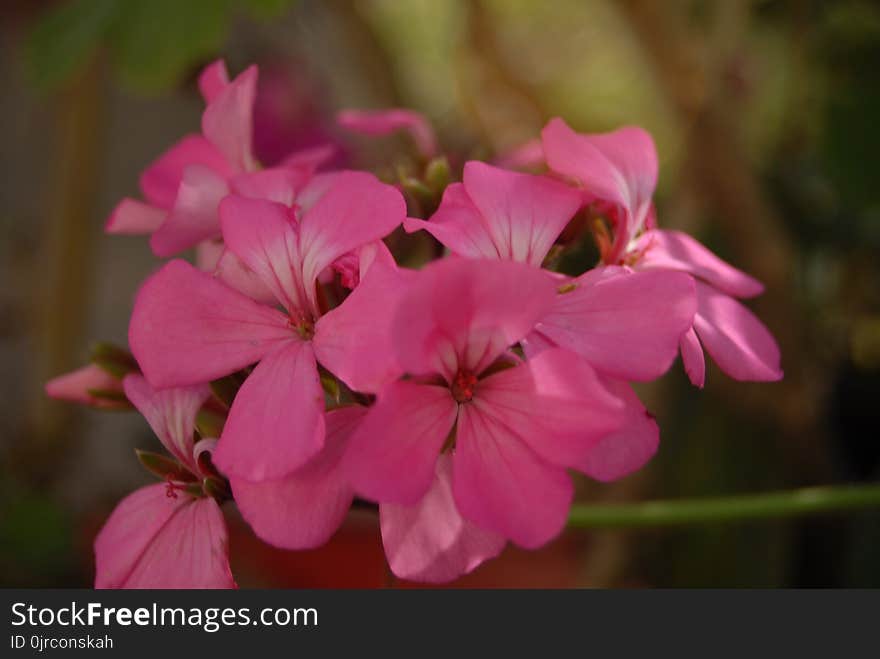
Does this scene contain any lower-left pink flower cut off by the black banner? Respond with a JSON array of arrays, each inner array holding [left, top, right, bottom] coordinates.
[[95, 375, 235, 588]]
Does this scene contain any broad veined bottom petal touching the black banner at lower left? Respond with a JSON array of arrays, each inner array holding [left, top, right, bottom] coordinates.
[[95, 483, 235, 588]]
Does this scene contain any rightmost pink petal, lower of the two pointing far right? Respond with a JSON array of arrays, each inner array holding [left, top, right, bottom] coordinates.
[[694, 282, 782, 382]]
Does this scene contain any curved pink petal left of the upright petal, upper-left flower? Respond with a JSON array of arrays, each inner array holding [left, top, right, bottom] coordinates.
[[140, 135, 232, 210]]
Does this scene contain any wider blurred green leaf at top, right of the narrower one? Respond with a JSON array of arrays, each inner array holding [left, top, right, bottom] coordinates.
[[111, 0, 232, 92]]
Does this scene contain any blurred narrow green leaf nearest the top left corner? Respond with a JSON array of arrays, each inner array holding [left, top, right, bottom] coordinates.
[[24, 0, 123, 91]]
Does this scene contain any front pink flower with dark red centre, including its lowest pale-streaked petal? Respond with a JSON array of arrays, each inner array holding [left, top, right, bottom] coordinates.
[[345, 258, 622, 580]]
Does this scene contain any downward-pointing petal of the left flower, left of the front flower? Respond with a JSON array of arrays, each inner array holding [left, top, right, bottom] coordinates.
[[214, 340, 324, 481]]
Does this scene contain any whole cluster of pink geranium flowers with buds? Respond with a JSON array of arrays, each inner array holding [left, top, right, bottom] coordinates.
[[47, 62, 782, 587]]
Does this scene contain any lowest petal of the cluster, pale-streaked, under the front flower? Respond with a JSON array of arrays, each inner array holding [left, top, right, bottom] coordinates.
[[379, 455, 505, 583]]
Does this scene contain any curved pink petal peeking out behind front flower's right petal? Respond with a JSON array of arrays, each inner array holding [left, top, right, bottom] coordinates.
[[575, 378, 660, 482]]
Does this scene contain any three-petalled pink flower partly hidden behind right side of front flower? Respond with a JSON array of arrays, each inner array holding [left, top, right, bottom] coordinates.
[[404, 162, 695, 480]]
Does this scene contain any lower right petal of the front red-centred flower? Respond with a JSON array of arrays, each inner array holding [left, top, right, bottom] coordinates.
[[452, 405, 574, 549]]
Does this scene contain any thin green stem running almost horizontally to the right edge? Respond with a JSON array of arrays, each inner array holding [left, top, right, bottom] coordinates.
[[568, 485, 880, 529]]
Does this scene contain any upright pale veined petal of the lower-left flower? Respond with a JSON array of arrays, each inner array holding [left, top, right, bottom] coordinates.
[[123, 373, 211, 474]]
